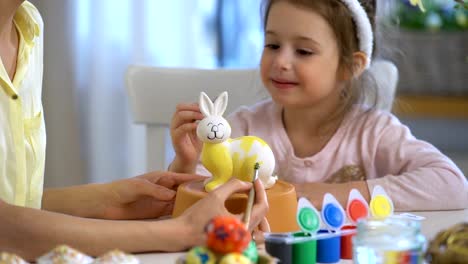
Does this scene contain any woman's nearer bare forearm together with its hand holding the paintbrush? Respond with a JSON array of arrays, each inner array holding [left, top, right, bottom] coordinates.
[[0, 179, 268, 260]]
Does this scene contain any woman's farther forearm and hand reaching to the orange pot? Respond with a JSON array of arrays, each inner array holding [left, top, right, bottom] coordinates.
[[43, 171, 204, 219]]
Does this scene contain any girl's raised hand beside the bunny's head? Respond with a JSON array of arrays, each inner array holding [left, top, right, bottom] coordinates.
[[169, 103, 204, 173]]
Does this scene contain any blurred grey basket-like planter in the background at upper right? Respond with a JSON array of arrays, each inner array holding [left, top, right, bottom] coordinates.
[[384, 30, 468, 95]]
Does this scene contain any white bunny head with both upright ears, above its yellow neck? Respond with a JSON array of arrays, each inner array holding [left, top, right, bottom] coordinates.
[[197, 92, 231, 143]]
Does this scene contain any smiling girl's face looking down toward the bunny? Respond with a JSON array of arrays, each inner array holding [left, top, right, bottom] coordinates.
[[260, 1, 341, 108]]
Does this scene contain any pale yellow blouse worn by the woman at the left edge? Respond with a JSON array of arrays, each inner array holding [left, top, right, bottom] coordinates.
[[0, 1, 46, 208]]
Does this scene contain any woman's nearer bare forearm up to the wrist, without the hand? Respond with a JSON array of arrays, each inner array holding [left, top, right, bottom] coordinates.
[[0, 201, 191, 260]]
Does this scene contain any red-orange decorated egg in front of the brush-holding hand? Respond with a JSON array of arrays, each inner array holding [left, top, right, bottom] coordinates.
[[205, 216, 251, 254]]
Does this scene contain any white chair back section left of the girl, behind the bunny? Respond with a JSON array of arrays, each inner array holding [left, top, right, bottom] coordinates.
[[126, 66, 265, 170]]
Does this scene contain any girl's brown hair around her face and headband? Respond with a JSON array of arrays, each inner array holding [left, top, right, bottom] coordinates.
[[262, 0, 378, 127]]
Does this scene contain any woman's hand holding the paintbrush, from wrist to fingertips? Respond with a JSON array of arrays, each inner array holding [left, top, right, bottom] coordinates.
[[175, 178, 269, 248]]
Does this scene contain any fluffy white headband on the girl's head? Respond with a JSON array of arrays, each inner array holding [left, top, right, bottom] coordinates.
[[340, 0, 374, 68]]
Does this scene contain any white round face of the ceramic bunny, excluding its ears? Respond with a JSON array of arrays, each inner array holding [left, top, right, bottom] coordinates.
[[197, 116, 231, 143]]
